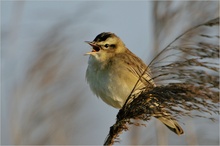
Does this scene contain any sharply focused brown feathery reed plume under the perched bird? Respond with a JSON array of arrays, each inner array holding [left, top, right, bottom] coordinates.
[[104, 18, 219, 145]]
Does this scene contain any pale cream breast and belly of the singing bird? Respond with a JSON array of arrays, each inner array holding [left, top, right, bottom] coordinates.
[[86, 57, 136, 108]]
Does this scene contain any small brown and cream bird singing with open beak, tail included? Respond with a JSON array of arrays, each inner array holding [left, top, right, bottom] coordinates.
[[86, 32, 183, 135]]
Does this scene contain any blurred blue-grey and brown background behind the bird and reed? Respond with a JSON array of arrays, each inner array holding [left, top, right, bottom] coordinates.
[[1, 0, 219, 145]]
